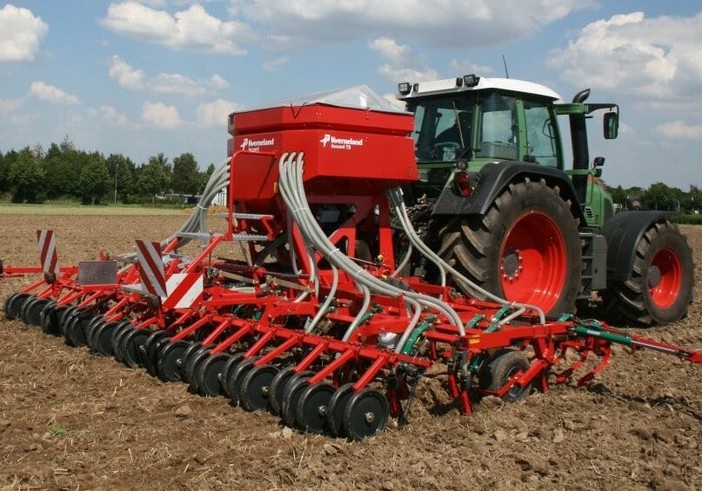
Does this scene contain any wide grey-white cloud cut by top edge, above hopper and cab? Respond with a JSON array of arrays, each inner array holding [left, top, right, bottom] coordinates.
[[230, 0, 596, 48]]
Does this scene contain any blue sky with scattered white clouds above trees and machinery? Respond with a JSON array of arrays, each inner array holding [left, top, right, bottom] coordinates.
[[0, 0, 702, 190]]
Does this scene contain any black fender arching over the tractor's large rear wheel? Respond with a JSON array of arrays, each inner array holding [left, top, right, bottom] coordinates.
[[432, 162, 586, 224]]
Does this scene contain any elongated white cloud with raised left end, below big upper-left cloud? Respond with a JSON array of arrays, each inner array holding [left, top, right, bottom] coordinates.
[[108, 55, 229, 97]]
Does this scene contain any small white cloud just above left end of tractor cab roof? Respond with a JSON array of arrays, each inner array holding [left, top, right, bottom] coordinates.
[[368, 37, 438, 82]]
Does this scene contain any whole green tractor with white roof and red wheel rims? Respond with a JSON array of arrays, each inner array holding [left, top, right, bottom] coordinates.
[[398, 75, 694, 326]]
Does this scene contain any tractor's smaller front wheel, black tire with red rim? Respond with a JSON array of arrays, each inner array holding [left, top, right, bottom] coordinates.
[[602, 220, 695, 327]]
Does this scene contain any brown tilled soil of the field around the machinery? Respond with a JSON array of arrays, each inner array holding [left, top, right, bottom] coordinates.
[[0, 216, 702, 490]]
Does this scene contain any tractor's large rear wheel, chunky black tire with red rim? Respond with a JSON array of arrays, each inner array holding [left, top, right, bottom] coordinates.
[[438, 178, 582, 318]]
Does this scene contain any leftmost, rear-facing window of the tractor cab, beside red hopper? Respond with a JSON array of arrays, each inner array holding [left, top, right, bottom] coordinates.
[[408, 95, 473, 162]]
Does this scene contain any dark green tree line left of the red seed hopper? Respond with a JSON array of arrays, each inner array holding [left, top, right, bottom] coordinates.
[[0, 138, 214, 204]]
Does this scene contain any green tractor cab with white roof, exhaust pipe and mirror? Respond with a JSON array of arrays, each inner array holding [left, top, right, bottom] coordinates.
[[398, 75, 618, 228]]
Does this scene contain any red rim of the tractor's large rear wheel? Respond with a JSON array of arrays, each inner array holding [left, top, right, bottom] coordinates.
[[499, 212, 568, 312]]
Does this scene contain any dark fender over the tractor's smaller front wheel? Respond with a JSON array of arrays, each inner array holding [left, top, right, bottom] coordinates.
[[602, 211, 668, 281]]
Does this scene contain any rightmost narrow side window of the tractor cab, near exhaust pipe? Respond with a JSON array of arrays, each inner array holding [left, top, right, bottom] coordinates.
[[524, 101, 558, 167]]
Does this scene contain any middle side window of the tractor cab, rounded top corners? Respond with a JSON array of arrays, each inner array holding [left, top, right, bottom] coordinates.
[[475, 92, 519, 160]]
